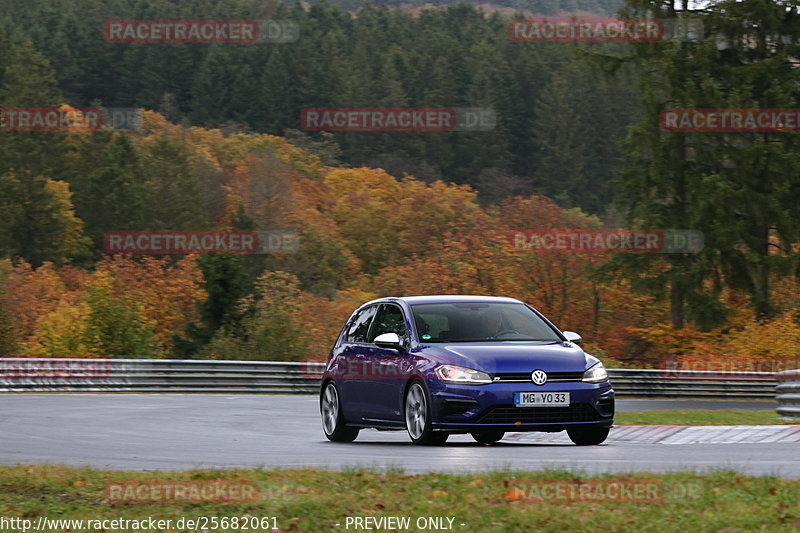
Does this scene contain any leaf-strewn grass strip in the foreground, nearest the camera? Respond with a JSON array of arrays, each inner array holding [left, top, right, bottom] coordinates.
[[0, 465, 800, 533]]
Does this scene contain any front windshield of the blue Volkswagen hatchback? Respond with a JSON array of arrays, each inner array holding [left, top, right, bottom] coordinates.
[[411, 302, 561, 342]]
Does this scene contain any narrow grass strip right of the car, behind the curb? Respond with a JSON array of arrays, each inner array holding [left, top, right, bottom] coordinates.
[[614, 409, 791, 426]]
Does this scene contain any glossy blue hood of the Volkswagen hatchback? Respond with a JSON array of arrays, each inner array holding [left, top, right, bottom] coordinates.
[[422, 342, 598, 374]]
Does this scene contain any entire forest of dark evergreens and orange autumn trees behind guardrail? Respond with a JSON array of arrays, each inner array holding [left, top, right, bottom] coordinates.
[[0, 0, 800, 367]]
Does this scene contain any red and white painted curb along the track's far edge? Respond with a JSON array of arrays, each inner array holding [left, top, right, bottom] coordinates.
[[503, 425, 800, 444]]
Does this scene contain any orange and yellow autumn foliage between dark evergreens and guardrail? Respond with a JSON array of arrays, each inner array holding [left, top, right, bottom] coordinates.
[[0, 112, 800, 367]]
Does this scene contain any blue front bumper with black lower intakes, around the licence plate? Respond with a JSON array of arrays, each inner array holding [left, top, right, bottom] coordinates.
[[428, 380, 614, 432]]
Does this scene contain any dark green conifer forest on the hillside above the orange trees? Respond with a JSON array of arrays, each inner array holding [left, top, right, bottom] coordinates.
[[0, 0, 637, 213]]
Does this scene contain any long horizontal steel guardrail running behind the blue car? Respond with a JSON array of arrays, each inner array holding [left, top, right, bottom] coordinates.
[[0, 358, 780, 396]]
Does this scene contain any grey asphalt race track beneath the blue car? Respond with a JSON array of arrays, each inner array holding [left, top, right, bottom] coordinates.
[[0, 393, 800, 478]]
